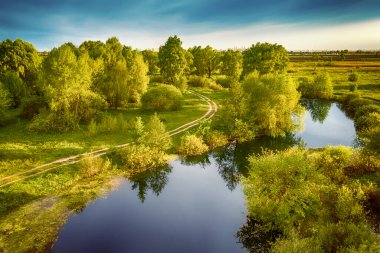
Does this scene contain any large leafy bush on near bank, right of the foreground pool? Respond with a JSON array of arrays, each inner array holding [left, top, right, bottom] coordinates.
[[243, 150, 320, 235]]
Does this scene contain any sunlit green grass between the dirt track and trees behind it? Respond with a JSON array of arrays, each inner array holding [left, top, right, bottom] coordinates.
[[0, 93, 208, 178]]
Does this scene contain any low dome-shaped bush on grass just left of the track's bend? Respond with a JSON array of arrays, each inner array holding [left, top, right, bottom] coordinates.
[[141, 84, 182, 111]]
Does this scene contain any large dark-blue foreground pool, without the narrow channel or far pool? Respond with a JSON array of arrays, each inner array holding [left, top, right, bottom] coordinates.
[[54, 156, 246, 253]]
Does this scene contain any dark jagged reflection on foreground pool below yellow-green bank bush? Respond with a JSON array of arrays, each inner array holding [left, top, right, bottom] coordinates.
[[128, 164, 172, 203]]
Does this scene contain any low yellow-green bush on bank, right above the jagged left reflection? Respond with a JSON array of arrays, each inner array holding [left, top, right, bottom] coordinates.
[[118, 144, 166, 173]]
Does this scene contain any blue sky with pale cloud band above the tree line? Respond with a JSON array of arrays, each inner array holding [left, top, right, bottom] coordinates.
[[0, 0, 380, 51]]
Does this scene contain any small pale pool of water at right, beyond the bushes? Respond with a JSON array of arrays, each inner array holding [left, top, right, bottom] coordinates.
[[296, 100, 356, 148]]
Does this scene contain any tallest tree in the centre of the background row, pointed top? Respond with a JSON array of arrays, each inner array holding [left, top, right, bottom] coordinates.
[[158, 36, 188, 84]]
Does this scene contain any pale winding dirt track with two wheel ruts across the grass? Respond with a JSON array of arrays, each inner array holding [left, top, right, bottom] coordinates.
[[0, 90, 218, 188]]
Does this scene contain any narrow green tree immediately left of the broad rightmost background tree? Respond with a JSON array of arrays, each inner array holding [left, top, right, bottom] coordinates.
[[221, 49, 243, 80]]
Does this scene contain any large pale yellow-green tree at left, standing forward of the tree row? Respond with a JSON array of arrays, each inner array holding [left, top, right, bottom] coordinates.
[[32, 44, 104, 131]]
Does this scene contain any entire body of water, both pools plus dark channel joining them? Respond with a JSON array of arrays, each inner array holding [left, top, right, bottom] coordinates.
[[53, 101, 355, 253]]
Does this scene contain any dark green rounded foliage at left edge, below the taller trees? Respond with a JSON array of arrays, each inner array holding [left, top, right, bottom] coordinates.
[[1, 71, 26, 107]]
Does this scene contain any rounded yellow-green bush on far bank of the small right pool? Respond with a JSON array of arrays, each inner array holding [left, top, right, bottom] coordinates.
[[298, 73, 334, 99]]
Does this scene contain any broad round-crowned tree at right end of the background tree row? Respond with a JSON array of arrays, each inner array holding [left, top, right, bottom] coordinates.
[[243, 42, 289, 76]]
